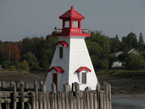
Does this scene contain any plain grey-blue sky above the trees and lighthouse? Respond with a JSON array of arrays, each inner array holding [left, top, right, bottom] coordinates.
[[0, 0, 145, 41]]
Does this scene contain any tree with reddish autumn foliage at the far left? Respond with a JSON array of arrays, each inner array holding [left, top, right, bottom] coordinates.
[[3, 43, 20, 62]]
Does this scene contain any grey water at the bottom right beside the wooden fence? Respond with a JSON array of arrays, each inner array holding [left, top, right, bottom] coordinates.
[[112, 94, 145, 109]]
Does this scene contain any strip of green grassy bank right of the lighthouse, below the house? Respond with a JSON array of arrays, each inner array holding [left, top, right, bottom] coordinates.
[[96, 70, 145, 79]]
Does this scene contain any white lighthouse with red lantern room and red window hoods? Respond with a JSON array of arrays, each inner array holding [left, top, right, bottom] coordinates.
[[45, 6, 98, 92]]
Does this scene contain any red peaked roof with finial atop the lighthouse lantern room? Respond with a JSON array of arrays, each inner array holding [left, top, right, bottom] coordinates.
[[59, 6, 85, 19]]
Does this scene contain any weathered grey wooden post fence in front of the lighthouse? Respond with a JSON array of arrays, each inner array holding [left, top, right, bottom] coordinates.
[[0, 81, 111, 109]]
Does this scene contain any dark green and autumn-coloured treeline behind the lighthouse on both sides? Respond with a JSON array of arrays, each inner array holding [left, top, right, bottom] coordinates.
[[0, 31, 145, 71]]
